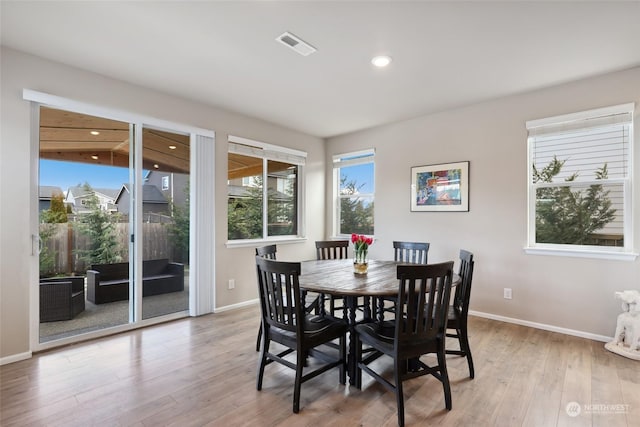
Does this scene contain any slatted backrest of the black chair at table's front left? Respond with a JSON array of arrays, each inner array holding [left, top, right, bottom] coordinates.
[[256, 255, 304, 333]]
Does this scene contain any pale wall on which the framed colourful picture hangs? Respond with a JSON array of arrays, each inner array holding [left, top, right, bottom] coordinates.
[[326, 68, 640, 338]]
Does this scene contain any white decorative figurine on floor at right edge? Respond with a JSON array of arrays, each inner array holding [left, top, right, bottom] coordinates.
[[604, 290, 640, 360]]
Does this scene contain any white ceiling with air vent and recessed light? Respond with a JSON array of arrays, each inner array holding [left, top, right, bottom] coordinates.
[[1, 0, 640, 137]]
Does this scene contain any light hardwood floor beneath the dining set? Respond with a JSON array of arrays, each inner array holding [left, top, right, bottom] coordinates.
[[0, 307, 640, 427]]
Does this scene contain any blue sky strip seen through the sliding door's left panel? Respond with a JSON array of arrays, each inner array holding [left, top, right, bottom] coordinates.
[[40, 159, 129, 192]]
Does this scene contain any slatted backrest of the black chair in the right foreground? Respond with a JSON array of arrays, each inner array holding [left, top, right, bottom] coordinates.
[[395, 261, 453, 351]]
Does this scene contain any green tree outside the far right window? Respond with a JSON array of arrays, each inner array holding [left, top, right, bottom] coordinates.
[[533, 156, 616, 245]]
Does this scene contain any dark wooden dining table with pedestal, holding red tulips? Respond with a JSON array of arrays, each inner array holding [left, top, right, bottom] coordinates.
[[299, 259, 460, 387]]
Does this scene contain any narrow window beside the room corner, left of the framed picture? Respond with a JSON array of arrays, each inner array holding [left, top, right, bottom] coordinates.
[[333, 150, 375, 236]]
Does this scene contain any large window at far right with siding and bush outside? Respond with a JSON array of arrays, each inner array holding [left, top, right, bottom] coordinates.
[[527, 104, 633, 260]]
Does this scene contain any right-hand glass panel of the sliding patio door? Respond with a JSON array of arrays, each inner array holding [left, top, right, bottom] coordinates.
[[139, 126, 190, 319]]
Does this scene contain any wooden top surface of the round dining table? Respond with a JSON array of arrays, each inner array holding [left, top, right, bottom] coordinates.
[[299, 259, 460, 296]]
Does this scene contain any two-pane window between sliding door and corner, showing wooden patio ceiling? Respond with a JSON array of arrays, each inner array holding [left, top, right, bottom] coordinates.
[[227, 136, 307, 240]]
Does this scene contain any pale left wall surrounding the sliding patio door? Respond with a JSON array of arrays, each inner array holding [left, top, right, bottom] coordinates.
[[0, 47, 325, 361]]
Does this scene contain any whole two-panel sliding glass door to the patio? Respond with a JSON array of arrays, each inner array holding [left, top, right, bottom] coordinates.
[[38, 107, 190, 343]]
